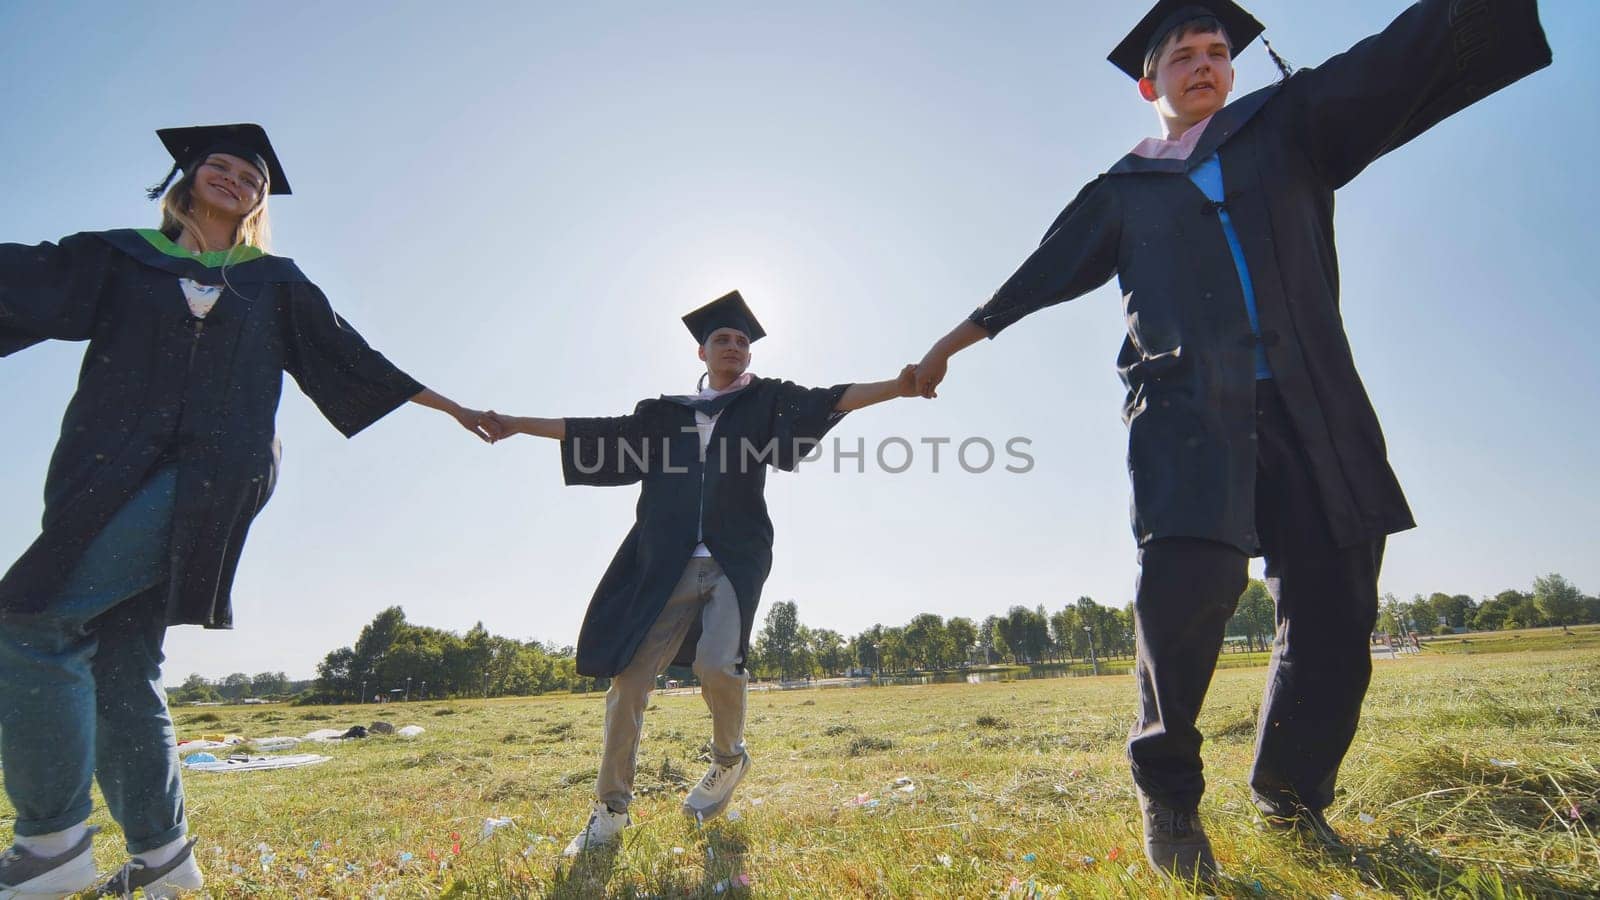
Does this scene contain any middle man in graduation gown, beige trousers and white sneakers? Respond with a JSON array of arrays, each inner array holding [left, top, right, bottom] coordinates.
[[491, 291, 917, 855]]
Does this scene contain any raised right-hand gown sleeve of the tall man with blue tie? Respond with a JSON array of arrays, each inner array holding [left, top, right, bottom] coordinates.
[[1283, 0, 1550, 189]]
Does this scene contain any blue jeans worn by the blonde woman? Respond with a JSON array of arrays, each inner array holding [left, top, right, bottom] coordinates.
[[0, 466, 184, 854]]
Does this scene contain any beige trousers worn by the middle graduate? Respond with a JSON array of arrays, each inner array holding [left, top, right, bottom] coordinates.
[[595, 556, 749, 812]]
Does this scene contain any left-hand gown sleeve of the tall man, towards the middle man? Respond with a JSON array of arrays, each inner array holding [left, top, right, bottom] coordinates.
[[968, 176, 1122, 338]]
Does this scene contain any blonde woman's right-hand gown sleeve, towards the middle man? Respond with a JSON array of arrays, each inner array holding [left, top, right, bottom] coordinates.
[[283, 282, 422, 437]]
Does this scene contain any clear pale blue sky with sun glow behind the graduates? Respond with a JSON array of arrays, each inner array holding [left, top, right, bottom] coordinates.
[[0, 0, 1600, 682]]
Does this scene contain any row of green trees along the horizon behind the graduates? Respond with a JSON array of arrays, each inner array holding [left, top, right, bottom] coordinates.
[[222, 575, 1600, 703]]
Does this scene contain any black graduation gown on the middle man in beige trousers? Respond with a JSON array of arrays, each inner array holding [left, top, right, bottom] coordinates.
[[562, 378, 850, 677]]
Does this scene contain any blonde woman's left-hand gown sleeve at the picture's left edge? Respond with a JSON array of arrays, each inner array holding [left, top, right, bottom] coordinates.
[[0, 234, 114, 356]]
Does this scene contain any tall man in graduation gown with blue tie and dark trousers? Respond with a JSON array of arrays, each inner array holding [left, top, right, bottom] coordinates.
[[918, 0, 1550, 878]]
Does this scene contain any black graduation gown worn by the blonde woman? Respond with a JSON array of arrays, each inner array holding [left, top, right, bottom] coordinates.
[[0, 231, 422, 628]]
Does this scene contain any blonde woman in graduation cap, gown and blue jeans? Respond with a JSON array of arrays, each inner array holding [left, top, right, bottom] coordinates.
[[0, 125, 486, 900]]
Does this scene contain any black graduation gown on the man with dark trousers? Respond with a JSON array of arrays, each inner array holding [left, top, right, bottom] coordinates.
[[971, 0, 1550, 554]]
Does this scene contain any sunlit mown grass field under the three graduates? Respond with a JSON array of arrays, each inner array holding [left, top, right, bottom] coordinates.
[[12, 636, 1600, 898]]
